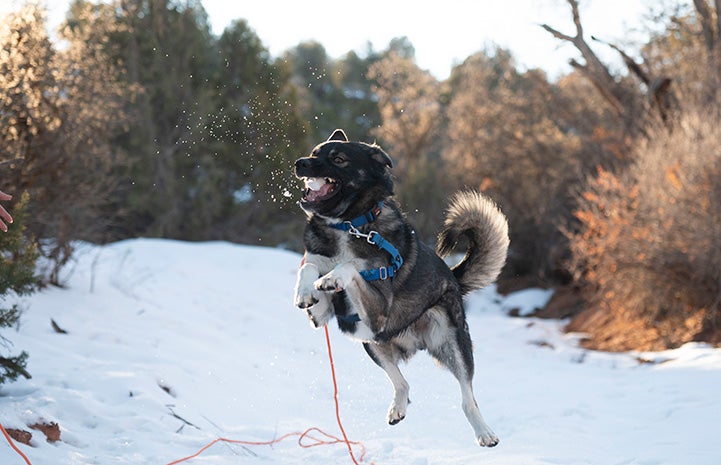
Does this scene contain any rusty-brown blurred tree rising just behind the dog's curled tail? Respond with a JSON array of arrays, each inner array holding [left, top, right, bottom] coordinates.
[[443, 48, 582, 284]]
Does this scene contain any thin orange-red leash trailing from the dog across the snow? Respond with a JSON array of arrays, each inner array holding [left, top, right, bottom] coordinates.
[[0, 325, 373, 465]]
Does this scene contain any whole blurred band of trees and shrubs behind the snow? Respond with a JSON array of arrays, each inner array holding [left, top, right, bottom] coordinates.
[[0, 0, 721, 350]]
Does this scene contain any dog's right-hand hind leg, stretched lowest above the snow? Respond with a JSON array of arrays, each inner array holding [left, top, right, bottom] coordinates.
[[425, 303, 498, 447]]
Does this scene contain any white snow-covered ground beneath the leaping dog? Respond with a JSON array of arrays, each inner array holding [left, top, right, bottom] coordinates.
[[0, 239, 721, 465]]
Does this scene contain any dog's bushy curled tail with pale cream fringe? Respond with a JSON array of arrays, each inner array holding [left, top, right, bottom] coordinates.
[[436, 190, 510, 295]]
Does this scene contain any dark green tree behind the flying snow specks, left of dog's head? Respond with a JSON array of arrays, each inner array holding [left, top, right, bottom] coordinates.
[[207, 21, 310, 243]]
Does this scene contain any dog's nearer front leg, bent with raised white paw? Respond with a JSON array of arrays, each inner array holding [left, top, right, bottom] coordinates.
[[314, 261, 388, 334]]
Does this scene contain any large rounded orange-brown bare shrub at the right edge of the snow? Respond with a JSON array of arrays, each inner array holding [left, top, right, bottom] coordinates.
[[568, 101, 721, 350]]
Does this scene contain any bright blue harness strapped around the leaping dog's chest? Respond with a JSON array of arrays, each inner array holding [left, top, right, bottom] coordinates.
[[331, 202, 403, 323]]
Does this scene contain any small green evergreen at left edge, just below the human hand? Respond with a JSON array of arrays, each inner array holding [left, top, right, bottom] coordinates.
[[0, 193, 38, 384]]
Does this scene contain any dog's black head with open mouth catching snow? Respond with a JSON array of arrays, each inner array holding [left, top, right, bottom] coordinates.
[[295, 129, 393, 220]]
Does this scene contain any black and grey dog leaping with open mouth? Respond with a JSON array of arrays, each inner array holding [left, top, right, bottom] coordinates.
[[295, 129, 509, 447]]
